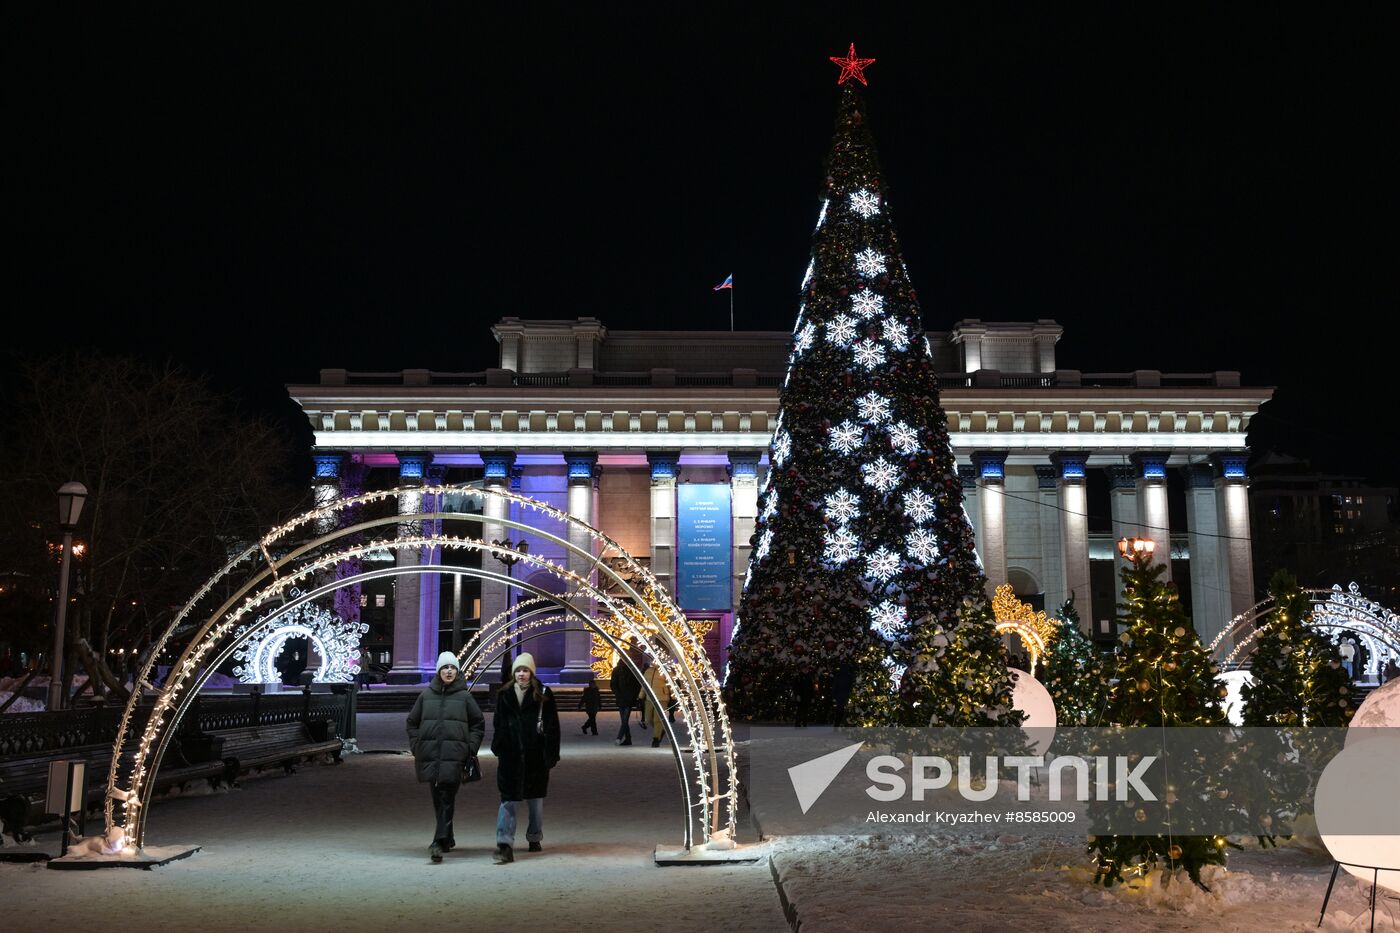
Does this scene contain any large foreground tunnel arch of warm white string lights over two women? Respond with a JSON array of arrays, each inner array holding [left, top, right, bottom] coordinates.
[[105, 486, 738, 850]]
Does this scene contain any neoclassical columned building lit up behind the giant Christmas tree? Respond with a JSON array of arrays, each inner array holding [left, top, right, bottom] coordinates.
[[288, 318, 1273, 682]]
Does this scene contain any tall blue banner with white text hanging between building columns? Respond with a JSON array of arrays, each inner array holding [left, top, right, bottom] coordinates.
[[676, 483, 734, 611]]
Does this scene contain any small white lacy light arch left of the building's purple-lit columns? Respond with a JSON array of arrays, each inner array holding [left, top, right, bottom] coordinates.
[[234, 602, 370, 684]]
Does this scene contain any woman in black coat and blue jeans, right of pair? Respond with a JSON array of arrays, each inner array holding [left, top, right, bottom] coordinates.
[[491, 653, 559, 864]]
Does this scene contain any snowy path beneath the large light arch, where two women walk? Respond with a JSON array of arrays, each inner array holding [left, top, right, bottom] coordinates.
[[0, 713, 788, 933]]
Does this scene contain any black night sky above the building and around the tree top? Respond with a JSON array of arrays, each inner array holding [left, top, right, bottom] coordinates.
[[3, 1, 1400, 483]]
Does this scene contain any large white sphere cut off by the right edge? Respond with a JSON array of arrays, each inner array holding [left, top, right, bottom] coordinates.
[[1313, 731, 1400, 892]]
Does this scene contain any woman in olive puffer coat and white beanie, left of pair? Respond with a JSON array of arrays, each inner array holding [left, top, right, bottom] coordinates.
[[409, 651, 486, 862]]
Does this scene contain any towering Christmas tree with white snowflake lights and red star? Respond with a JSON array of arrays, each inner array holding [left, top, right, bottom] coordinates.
[[727, 48, 1016, 724]]
